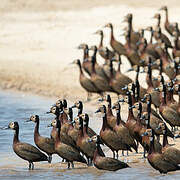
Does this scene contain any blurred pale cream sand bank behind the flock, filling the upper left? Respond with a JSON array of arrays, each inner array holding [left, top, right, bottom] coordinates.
[[0, 0, 180, 99]]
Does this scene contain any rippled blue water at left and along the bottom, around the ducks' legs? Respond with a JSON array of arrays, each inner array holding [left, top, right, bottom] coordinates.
[[0, 91, 180, 180]]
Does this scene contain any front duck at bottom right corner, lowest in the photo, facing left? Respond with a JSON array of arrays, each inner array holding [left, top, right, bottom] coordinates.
[[144, 129, 180, 174]]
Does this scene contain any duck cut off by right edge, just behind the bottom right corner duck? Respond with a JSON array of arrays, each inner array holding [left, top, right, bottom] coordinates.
[[158, 123, 180, 164]]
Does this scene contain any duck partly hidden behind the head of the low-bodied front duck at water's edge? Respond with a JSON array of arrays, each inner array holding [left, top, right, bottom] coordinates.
[[75, 116, 105, 165]]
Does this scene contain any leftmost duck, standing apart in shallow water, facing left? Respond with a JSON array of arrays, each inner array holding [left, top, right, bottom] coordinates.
[[6, 122, 48, 170]]
